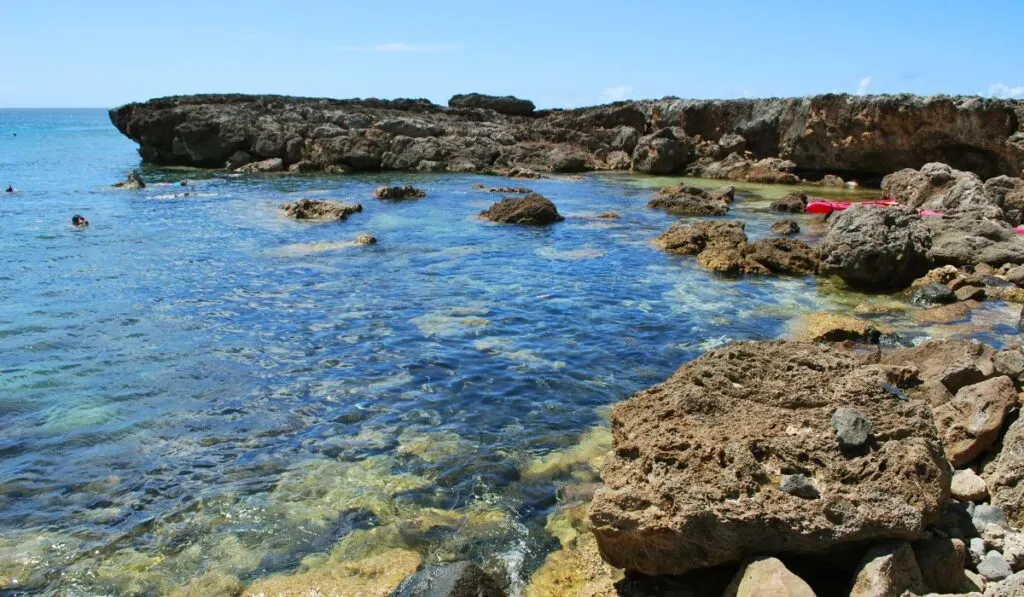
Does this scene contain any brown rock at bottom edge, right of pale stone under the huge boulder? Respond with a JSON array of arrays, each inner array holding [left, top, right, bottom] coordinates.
[[850, 542, 927, 597]]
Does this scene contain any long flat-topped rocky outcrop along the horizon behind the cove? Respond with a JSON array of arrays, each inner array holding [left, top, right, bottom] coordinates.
[[111, 94, 1024, 177]]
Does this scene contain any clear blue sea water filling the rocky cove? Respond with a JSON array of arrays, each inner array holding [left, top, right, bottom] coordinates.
[[0, 111, 1015, 595]]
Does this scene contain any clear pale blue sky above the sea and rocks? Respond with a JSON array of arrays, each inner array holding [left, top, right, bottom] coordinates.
[[0, 0, 1024, 108]]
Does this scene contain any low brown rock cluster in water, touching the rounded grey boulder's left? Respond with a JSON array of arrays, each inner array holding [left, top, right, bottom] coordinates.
[[655, 221, 818, 275]]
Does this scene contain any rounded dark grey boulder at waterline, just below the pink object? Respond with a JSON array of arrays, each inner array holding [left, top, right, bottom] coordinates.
[[818, 205, 931, 289]]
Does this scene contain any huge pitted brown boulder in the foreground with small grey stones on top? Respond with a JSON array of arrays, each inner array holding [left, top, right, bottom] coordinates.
[[591, 341, 950, 575]]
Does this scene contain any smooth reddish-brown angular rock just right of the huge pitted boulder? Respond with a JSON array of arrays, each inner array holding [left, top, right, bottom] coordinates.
[[933, 376, 1017, 467]]
